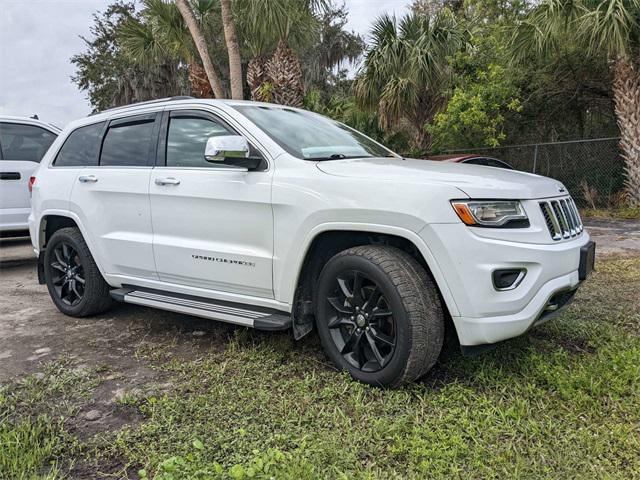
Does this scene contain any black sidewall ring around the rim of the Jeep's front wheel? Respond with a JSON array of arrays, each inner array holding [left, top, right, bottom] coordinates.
[[315, 255, 411, 386]]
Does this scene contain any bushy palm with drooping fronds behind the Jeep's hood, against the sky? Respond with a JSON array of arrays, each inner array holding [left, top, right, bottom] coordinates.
[[355, 9, 468, 150]]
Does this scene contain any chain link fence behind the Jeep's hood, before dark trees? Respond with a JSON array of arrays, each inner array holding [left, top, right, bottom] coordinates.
[[445, 137, 624, 208]]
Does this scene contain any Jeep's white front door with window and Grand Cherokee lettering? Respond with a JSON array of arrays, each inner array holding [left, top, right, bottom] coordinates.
[[150, 110, 273, 298]]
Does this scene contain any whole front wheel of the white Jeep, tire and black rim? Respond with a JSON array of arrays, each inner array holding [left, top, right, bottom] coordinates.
[[314, 245, 444, 388]]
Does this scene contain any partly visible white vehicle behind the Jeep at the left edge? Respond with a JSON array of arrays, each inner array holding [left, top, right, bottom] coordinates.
[[0, 116, 60, 234]]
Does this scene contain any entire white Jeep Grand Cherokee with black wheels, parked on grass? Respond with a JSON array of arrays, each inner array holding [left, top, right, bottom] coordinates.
[[29, 98, 595, 386]]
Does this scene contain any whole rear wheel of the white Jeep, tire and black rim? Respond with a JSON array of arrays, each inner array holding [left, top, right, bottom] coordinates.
[[44, 228, 113, 317]]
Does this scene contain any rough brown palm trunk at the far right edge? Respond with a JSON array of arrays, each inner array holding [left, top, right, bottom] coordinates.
[[613, 56, 640, 208]]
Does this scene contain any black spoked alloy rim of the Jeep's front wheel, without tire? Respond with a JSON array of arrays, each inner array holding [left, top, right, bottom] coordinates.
[[326, 270, 396, 372]]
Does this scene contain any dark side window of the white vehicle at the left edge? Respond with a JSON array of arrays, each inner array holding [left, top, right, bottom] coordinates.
[[0, 123, 57, 162]]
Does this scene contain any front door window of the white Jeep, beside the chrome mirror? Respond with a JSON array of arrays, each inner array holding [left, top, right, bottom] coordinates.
[[167, 117, 234, 167]]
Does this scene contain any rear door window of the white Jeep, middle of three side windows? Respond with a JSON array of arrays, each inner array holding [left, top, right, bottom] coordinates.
[[100, 120, 154, 167]]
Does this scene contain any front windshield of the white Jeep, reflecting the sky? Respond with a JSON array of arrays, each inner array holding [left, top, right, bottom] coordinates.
[[233, 105, 397, 160]]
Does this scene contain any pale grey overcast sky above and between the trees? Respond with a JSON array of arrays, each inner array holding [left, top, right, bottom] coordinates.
[[0, 0, 411, 127]]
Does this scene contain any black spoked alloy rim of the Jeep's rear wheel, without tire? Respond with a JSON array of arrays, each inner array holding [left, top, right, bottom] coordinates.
[[50, 241, 86, 307]]
